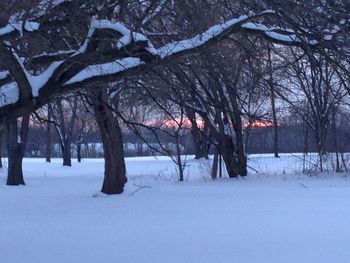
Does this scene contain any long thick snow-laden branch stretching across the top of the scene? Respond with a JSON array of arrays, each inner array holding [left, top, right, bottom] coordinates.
[[0, 4, 346, 117]]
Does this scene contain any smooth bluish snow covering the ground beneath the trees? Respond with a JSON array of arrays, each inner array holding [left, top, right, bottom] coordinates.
[[0, 155, 350, 263]]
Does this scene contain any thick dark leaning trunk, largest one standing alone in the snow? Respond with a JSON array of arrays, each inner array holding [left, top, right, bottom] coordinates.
[[93, 89, 127, 194]]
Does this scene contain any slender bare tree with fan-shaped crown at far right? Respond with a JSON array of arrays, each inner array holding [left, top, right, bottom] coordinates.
[[280, 56, 346, 171]]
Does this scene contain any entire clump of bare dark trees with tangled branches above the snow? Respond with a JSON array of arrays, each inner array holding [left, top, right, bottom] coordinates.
[[0, 0, 350, 194]]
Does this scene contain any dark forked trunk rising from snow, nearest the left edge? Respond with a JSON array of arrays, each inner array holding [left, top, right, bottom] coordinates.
[[6, 115, 29, 188]]
